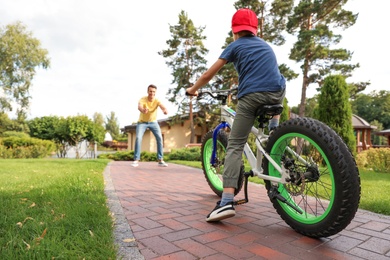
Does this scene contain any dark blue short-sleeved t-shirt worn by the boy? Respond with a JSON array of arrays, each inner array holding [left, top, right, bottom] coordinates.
[[219, 36, 286, 98]]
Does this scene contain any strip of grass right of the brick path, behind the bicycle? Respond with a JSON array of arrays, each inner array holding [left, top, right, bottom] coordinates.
[[171, 161, 390, 216]]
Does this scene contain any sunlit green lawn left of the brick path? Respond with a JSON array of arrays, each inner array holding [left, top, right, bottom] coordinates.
[[0, 159, 117, 259]]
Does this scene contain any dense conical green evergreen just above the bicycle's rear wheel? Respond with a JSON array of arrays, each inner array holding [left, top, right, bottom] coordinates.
[[316, 75, 356, 153]]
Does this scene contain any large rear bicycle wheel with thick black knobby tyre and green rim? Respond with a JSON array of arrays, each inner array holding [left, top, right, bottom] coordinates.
[[264, 118, 361, 238]]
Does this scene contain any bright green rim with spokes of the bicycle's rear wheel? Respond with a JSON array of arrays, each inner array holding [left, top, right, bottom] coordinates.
[[268, 133, 336, 225]]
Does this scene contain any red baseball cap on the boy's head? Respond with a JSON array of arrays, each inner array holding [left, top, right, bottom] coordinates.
[[232, 8, 259, 35]]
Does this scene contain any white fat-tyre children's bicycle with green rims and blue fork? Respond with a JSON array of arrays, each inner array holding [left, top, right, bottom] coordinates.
[[193, 88, 361, 238]]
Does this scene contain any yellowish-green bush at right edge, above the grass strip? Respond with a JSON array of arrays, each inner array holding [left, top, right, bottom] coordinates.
[[356, 148, 390, 173]]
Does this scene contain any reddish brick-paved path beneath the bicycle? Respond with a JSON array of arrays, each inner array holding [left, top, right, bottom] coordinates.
[[106, 162, 390, 260]]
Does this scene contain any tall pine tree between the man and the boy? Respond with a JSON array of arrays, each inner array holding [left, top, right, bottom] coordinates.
[[158, 10, 208, 143]]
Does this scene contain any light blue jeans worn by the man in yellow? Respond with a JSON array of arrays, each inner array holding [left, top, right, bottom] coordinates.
[[134, 122, 164, 161]]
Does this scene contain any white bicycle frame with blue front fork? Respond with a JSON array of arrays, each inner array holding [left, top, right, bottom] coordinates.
[[210, 105, 289, 184]]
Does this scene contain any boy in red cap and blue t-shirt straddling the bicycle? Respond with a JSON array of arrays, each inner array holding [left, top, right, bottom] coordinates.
[[186, 8, 286, 222]]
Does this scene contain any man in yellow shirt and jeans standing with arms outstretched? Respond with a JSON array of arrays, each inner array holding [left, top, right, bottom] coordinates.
[[132, 84, 168, 167]]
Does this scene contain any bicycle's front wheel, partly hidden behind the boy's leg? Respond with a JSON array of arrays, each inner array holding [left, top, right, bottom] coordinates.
[[201, 130, 244, 197]]
